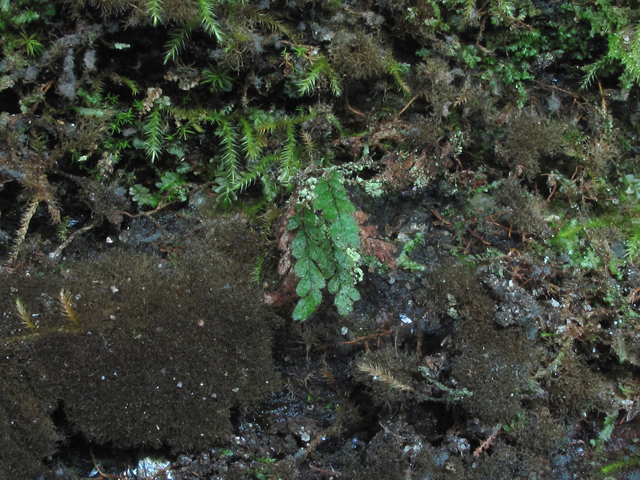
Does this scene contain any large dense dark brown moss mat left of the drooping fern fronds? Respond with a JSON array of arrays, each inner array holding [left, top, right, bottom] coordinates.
[[0, 220, 274, 450]]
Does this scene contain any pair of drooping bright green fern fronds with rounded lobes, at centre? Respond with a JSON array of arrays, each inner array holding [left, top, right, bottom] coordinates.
[[287, 171, 362, 321]]
